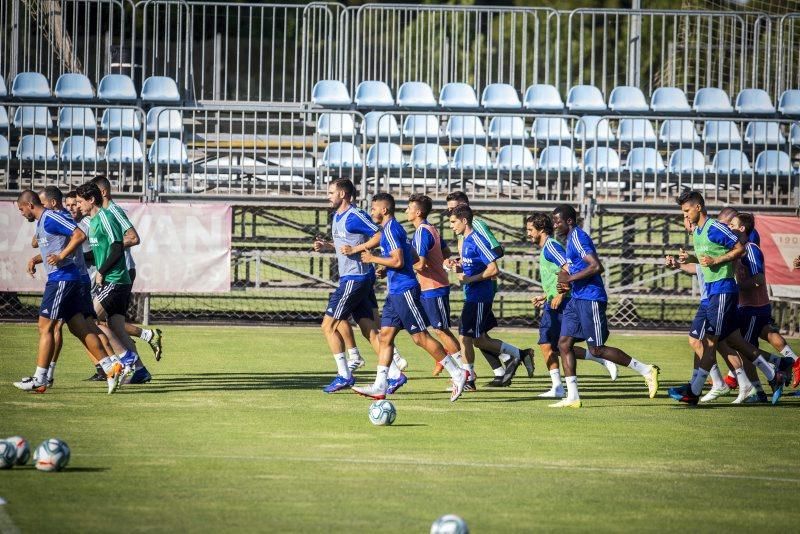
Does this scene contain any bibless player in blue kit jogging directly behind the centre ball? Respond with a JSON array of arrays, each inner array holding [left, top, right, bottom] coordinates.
[[353, 193, 467, 402]]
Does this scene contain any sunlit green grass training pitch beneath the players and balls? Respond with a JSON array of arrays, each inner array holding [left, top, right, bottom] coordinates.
[[0, 325, 800, 532]]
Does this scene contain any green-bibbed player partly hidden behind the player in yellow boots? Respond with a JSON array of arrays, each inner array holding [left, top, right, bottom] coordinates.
[[525, 213, 617, 398]]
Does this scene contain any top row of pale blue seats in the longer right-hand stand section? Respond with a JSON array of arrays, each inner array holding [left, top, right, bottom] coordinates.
[[311, 80, 800, 117]]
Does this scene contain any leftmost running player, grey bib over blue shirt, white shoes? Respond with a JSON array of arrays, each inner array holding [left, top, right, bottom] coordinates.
[[14, 189, 123, 394]]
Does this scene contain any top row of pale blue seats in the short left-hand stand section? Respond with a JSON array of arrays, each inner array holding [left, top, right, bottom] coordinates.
[[0, 72, 181, 104]]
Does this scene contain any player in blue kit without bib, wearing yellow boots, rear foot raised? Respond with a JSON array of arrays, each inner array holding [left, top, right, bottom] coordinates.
[[550, 204, 660, 408]]
